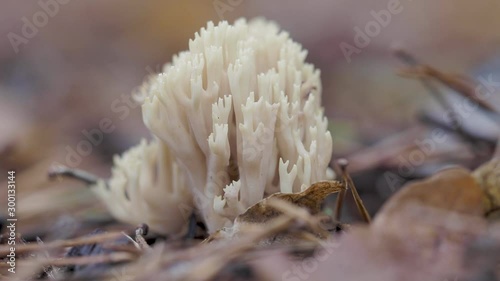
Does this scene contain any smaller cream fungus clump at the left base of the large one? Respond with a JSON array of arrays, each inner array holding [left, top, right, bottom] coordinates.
[[92, 138, 193, 235]]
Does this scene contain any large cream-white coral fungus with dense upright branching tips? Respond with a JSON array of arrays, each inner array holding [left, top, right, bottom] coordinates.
[[140, 19, 332, 232]]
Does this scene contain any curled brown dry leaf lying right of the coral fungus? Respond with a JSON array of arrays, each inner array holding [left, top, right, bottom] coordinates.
[[372, 167, 484, 239]]
